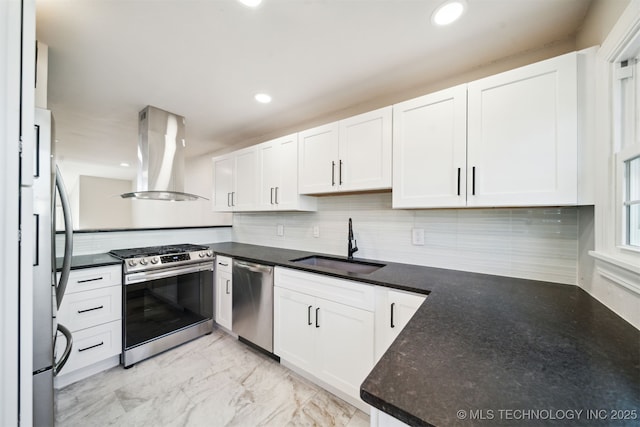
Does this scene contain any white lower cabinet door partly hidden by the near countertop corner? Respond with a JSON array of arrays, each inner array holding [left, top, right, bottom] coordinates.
[[376, 287, 426, 362]]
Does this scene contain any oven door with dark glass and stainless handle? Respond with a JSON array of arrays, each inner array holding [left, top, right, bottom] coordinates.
[[123, 262, 213, 350]]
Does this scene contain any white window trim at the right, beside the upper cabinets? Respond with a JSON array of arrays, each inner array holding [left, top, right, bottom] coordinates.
[[589, 0, 640, 275]]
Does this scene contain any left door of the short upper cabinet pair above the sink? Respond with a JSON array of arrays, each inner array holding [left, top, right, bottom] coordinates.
[[298, 122, 340, 194]]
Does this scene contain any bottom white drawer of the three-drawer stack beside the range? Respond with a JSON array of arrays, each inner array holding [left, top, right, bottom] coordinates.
[[56, 320, 122, 375]]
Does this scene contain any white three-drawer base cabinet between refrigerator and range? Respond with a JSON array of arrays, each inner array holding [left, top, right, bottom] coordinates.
[[55, 264, 122, 388]]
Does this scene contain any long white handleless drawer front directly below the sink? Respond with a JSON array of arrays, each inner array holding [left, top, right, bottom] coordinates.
[[274, 267, 375, 311]]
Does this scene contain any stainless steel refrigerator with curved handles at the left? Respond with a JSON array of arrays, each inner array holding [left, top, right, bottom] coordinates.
[[33, 108, 73, 426]]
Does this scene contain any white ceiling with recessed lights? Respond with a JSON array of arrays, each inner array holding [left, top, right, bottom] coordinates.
[[36, 0, 591, 171]]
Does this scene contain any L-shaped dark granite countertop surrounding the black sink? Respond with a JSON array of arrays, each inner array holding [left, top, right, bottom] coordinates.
[[210, 243, 640, 426]]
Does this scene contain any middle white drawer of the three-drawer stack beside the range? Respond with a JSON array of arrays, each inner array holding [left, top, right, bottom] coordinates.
[[58, 286, 122, 332]]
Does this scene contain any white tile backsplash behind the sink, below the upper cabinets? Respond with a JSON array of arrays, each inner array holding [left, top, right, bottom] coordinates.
[[232, 193, 578, 284]]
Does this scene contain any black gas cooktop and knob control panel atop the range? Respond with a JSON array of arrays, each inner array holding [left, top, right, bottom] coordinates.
[[109, 243, 213, 274]]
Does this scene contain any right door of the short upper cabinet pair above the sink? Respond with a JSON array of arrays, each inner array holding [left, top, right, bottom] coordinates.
[[337, 107, 392, 191]]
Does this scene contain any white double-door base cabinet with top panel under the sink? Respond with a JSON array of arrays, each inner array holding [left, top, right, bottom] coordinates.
[[274, 267, 374, 412]]
